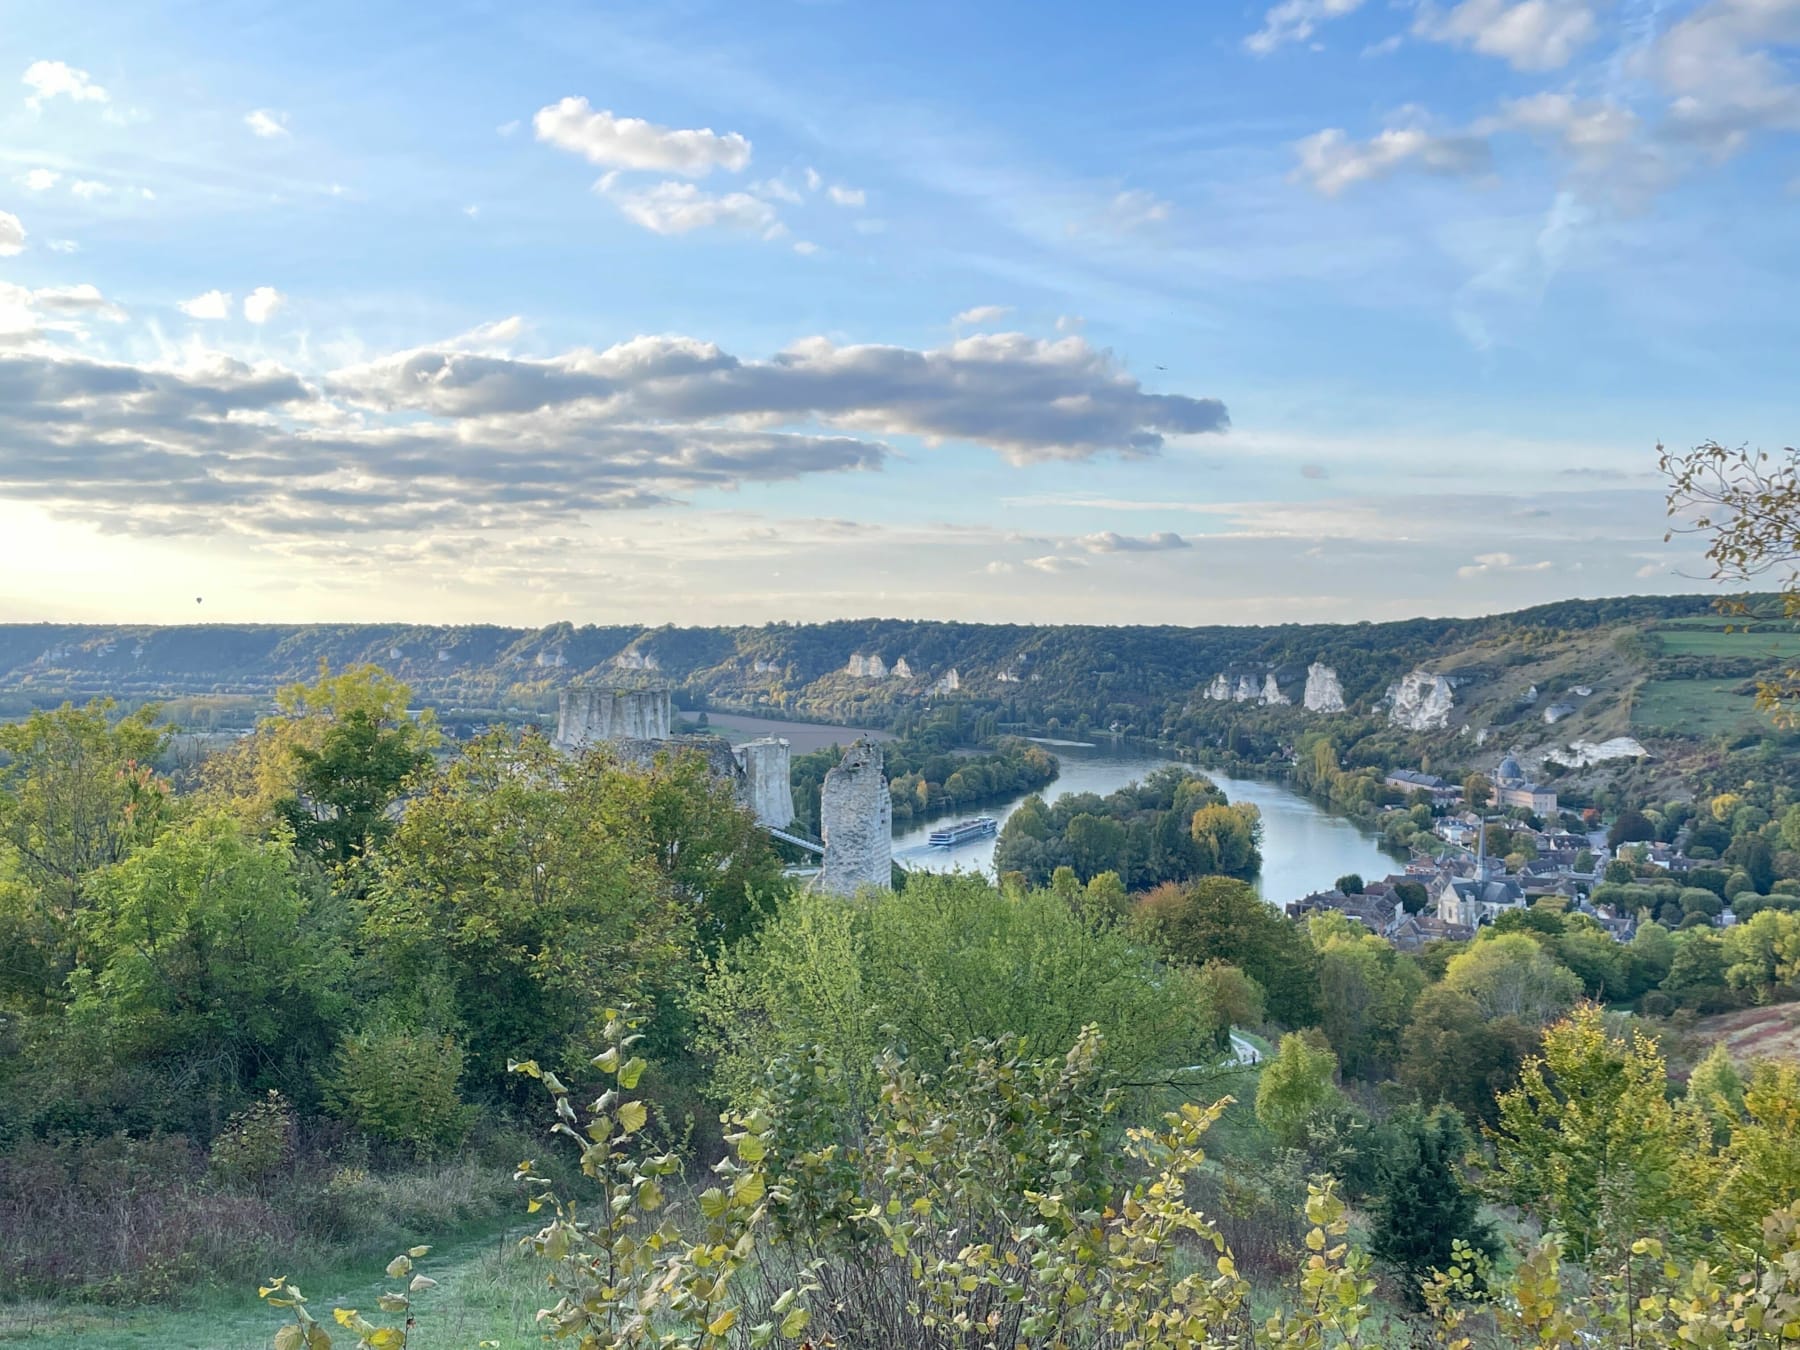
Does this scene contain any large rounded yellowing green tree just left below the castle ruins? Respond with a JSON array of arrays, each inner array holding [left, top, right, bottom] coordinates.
[[365, 733, 693, 1087]]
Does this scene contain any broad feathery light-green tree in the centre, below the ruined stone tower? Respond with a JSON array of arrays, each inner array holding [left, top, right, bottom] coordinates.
[[697, 877, 1220, 1102]]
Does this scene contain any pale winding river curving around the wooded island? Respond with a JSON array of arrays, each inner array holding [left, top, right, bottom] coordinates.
[[895, 742, 1400, 904]]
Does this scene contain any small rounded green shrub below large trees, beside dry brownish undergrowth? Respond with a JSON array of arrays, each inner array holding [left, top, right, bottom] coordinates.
[[324, 1028, 473, 1157]]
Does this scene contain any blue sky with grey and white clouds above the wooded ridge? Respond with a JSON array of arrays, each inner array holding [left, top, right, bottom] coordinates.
[[0, 0, 1800, 625]]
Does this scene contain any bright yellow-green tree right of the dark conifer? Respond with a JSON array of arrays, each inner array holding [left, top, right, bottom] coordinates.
[[1490, 1004, 1712, 1256]]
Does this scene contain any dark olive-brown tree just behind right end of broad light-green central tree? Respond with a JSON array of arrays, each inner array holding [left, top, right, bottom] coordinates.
[[1132, 877, 1318, 1026]]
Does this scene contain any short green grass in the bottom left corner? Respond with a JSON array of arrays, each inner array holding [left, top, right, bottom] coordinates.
[[0, 1228, 554, 1350]]
